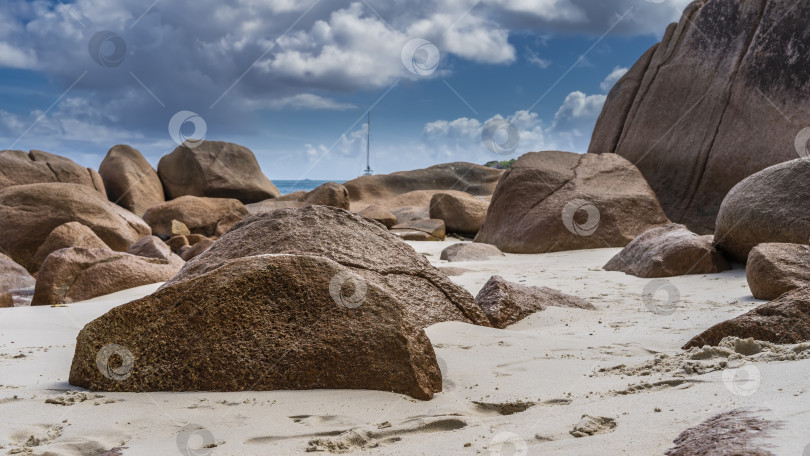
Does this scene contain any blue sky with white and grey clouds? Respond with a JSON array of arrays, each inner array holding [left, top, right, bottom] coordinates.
[[0, 0, 689, 180]]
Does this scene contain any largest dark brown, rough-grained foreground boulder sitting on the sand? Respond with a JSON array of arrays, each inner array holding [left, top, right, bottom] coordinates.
[[70, 255, 442, 400]]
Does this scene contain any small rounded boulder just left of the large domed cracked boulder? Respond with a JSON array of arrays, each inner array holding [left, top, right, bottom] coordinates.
[[430, 193, 489, 236]]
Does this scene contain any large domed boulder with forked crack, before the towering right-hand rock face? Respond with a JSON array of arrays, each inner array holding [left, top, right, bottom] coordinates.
[[475, 151, 669, 253]]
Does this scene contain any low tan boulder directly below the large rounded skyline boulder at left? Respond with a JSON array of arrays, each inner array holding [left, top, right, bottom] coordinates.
[[143, 196, 250, 236]]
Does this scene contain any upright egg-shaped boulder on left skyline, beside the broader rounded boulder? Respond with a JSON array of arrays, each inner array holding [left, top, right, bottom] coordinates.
[[98, 144, 166, 216]]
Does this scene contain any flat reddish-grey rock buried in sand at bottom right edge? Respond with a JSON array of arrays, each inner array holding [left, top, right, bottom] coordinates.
[[664, 409, 782, 456]]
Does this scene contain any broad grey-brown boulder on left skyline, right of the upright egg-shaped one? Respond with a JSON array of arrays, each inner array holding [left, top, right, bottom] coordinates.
[[157, 141, 281, 203]]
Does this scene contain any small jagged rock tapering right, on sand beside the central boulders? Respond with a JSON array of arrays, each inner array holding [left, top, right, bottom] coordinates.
[[475, 276, 596, 329]]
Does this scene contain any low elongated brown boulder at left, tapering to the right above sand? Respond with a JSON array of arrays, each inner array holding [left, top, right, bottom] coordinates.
[[31, 248, 184, 306]]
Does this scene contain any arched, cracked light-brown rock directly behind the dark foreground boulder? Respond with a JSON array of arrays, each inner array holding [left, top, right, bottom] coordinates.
[[165, 206, 482, 327]]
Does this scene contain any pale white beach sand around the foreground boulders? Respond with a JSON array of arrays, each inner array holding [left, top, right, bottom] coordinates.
[[0, 241, 810, 456]]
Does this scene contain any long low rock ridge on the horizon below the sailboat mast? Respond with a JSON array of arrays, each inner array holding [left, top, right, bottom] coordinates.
[[343, 162, 503, 210]]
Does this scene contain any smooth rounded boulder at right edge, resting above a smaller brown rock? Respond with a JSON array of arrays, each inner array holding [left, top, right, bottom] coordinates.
[[714, 159, 810, 263]]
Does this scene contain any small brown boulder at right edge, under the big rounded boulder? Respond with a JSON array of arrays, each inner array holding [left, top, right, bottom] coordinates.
[[745, 244, 810, 300]]
